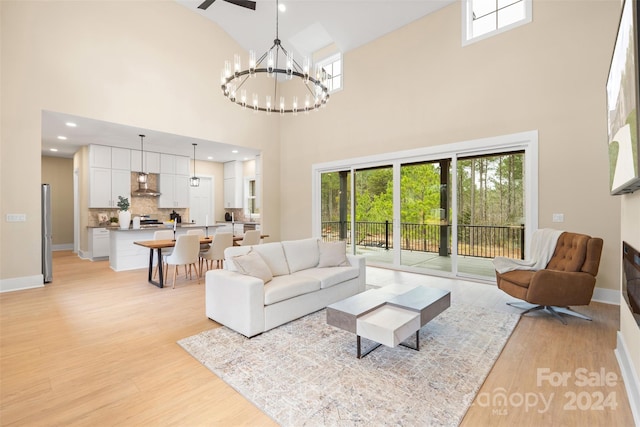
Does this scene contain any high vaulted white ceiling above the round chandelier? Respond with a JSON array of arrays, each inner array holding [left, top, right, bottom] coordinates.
[[176, 0, 456, 62]]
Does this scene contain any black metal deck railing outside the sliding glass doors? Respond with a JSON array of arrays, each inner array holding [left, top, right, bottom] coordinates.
[[322, 221, 524, 259]]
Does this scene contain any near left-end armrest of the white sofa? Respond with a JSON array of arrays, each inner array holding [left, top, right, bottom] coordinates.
[[205, 270, 264, 337]]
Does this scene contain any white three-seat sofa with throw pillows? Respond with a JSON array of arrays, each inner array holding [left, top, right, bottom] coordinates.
[[205, 238, 365, 337]]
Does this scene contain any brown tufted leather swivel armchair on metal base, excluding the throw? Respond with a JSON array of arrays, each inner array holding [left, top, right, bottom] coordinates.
[[496, 232, 603, 325]]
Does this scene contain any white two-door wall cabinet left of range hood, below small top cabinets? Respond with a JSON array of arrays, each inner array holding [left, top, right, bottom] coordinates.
[[89, 168, 131, 208]]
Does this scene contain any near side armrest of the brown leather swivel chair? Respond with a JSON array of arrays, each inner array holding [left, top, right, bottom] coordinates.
[[527, 270, 596, 307]]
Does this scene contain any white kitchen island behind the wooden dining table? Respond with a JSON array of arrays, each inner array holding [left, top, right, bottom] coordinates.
[[109, 223, 222, 271]]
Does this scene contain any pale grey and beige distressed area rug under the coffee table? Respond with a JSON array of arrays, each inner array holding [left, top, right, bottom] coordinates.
[[178, 304, 520, 426]]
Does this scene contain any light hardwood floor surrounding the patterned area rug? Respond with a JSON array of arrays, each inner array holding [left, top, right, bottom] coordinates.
[[0, 252, 633, 426]]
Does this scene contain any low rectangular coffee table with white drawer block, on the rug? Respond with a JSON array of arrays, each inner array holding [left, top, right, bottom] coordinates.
[[327, 284, 451, 359]]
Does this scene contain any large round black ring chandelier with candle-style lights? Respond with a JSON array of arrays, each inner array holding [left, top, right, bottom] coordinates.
[[221, 0, 329, 114]]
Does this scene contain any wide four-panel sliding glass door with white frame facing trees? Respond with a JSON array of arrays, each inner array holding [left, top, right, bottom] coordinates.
[[314, 134, 537, 280]]
